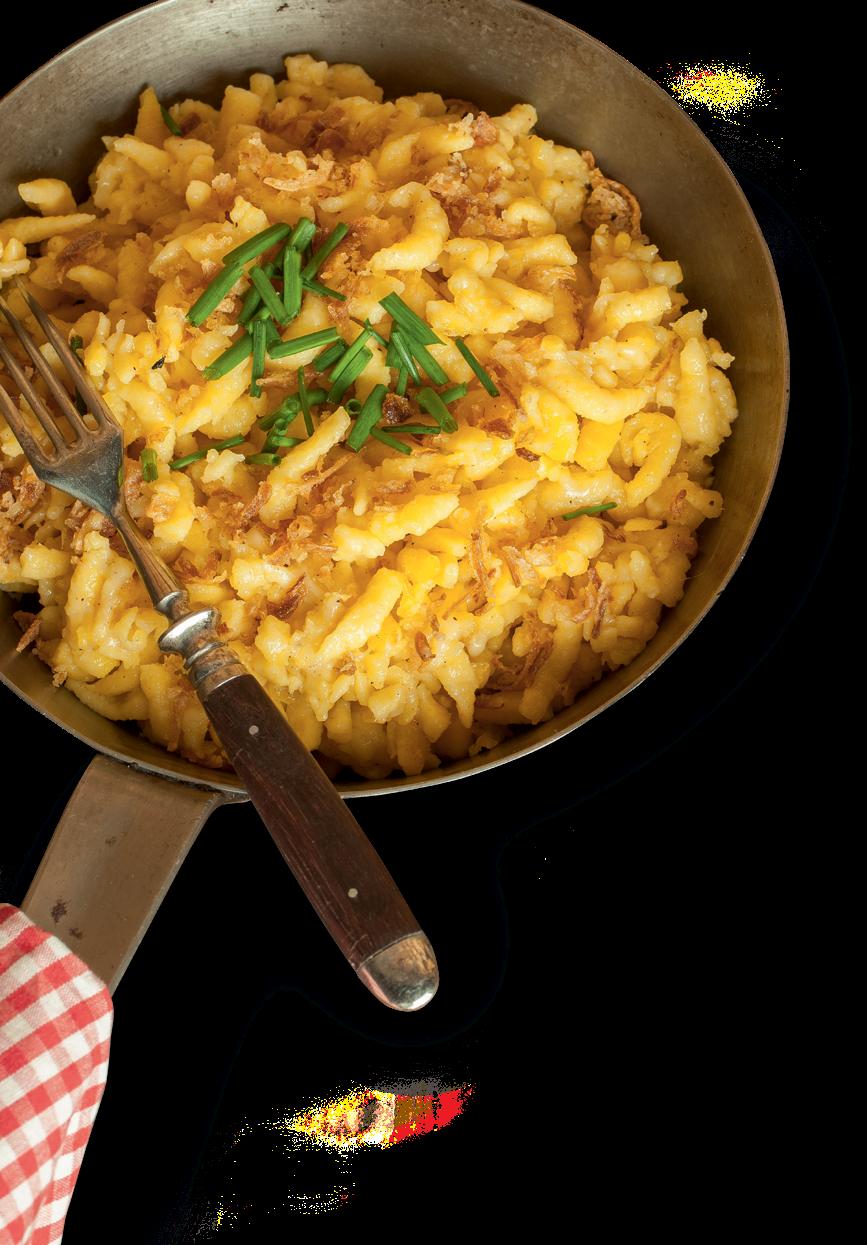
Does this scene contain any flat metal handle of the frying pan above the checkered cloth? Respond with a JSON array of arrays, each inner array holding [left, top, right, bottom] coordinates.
[[21, 756, 229, 992]]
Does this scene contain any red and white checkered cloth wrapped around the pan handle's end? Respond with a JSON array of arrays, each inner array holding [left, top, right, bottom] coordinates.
[[0, 904, 113, 1245]]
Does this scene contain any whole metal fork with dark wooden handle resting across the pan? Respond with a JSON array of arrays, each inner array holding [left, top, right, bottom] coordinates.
[[0, 280, 438, 1011]]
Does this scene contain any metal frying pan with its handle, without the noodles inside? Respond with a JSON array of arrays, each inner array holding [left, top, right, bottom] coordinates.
[[0, 0, 789, 989]]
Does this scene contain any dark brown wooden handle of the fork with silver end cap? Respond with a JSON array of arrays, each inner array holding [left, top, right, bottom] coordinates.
[[198, 674, 438, 1011]]
